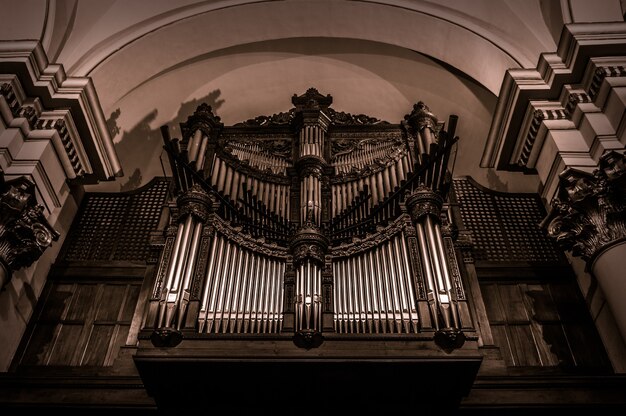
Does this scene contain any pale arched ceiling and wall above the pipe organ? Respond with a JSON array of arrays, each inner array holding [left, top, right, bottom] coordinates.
[[6, 0, 580, 191]]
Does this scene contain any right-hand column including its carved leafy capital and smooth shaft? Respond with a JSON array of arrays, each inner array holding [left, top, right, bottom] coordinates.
[[542, 150, 626, 340]]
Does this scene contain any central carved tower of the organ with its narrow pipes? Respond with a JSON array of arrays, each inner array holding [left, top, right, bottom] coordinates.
[[285, 88, 332, 347]]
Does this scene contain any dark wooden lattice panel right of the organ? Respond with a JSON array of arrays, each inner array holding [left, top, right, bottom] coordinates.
[[454, 178, 561, 263]]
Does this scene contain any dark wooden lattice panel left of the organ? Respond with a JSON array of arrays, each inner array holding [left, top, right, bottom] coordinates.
[[64, 179, 169, 261]]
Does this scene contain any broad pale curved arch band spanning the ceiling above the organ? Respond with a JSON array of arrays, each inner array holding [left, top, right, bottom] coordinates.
[[75, 1, 520, 100]]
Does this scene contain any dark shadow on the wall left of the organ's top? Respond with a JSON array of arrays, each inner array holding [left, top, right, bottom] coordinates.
[[106, 89, 224, 192]]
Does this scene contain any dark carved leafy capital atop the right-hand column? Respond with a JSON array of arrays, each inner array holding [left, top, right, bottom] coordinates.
[[541, 151, 626, 265]]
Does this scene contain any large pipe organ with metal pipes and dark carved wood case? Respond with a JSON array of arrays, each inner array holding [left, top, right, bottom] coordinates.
[[146, 88, 473, 348]]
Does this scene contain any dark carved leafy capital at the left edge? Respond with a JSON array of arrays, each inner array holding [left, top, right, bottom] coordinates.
[[0, 171, 59, 287]]
